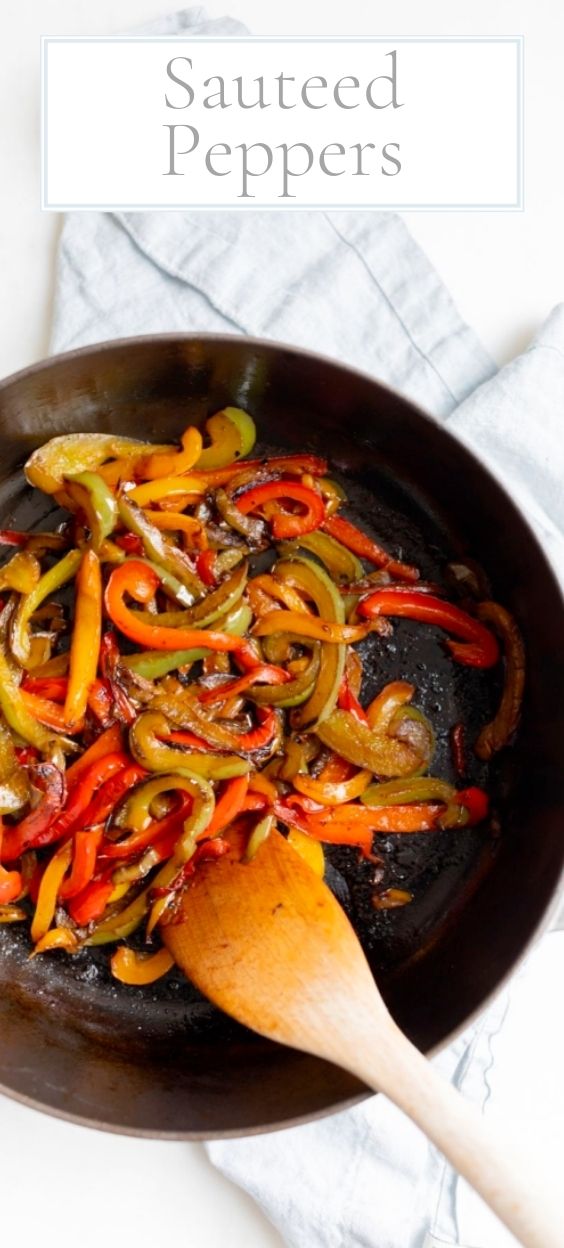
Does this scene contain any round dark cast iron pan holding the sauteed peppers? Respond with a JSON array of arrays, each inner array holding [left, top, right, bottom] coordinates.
[[0, 334, 564, 1138]]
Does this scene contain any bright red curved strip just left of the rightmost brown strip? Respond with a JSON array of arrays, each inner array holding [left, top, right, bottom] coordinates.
[[358, 585, 499, 668]]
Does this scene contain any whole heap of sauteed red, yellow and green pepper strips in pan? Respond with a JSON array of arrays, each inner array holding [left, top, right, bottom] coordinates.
[[0, 407, 516, 990]]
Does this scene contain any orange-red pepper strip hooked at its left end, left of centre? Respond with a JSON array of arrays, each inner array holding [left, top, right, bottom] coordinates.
[[105, 559, 245, 650]]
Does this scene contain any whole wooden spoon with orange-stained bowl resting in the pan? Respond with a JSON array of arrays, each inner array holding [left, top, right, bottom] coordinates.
[[162, 832, 564, 1248]]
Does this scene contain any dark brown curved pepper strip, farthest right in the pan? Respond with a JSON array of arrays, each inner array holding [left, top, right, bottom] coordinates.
[[474, 602, 525, 760]]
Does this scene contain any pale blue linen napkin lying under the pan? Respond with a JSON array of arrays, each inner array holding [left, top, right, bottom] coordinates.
[[51, 9, 564, 1248]]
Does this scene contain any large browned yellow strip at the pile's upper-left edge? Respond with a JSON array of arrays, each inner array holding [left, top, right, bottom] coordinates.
[[24, 433, 173, 494]]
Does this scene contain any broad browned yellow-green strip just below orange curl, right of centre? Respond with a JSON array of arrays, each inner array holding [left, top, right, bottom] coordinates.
[[316, 710, 422, 776]]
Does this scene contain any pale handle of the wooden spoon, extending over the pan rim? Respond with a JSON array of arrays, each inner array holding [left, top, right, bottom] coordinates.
[[346, 1018, 564, 1248]]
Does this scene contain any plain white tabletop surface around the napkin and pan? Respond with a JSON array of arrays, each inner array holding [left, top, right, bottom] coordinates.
[[0, 0, 564, 1248]]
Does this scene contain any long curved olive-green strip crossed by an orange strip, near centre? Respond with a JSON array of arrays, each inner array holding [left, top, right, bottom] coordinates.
[[276, 555, 347, 731]]
